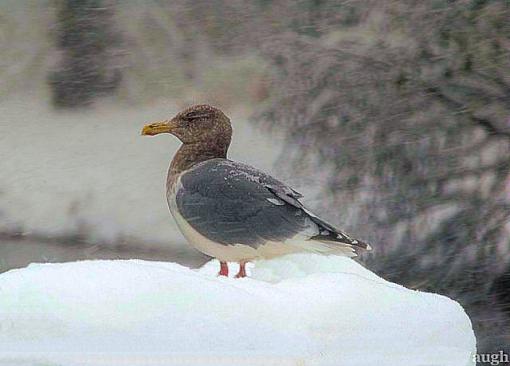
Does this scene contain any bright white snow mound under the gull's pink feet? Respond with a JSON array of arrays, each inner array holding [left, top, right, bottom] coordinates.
[[0, 254, 475, 366]]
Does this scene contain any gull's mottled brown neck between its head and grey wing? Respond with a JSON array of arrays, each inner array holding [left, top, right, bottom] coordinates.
[[168, 139, 230, 177]]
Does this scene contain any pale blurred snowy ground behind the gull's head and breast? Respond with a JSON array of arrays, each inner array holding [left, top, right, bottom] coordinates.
[[0, 99, 284, 245]]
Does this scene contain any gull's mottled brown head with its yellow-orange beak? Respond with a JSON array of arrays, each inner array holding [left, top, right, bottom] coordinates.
[[142, 104, 232, 146]]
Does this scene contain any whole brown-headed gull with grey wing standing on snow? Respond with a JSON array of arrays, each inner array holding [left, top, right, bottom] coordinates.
[[142, 104, 371, 278]]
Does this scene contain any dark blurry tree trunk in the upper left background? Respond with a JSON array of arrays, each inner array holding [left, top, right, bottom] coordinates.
[[49, 0, 121, 108]]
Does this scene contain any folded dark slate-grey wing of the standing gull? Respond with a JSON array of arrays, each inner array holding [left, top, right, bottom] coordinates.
[[176, 159, 366, 248]]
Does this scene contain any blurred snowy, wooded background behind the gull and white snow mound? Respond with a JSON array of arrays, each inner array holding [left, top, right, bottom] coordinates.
[[0, 0, 510, 360]]
